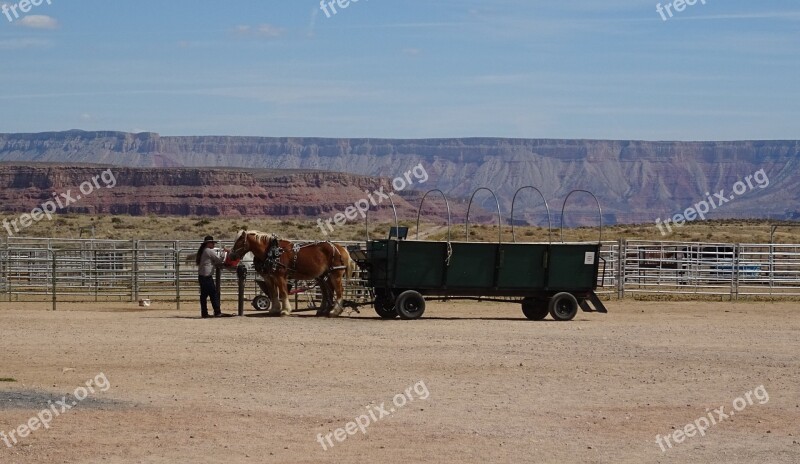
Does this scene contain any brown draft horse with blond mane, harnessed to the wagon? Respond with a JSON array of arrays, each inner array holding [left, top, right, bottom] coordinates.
[[230, 230, 355, 316]]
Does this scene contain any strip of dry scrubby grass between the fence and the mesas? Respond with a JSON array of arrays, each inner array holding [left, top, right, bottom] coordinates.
[[2, 214, 800, 243]]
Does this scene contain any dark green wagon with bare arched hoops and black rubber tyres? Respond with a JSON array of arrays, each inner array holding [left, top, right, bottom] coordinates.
[[354, 187, 607, 321]]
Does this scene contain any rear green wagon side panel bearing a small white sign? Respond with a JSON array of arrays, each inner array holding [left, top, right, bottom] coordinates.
[[547, 244, 600, 290]]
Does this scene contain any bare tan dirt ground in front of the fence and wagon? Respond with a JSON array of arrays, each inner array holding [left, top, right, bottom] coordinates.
[[0, 301, 800, 463]]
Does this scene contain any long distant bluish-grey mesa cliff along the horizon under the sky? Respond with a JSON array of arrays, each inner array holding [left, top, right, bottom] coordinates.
[[0, 131, 800, 223]]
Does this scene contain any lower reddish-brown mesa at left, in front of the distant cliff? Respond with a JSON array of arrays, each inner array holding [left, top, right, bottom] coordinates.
[[0, 163, 418, 219]]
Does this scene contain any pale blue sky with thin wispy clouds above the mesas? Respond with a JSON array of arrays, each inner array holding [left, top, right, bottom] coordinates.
[[0, 0, 800, 140]]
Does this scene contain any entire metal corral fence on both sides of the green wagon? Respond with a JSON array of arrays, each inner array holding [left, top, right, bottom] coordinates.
[[0, 237, 800, 309]]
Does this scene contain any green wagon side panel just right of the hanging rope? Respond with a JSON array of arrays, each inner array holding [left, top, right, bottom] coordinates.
[[440, 243, 497, 288]]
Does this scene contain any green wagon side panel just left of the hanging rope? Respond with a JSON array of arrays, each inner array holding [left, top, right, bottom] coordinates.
[[389, 241, 447, 289]]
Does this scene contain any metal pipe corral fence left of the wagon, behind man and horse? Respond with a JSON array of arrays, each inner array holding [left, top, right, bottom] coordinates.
[[0, 237, 365, 309]]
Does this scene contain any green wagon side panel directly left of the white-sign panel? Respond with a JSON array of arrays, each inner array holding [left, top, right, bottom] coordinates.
[[497, 243, 547, 289]]
